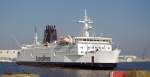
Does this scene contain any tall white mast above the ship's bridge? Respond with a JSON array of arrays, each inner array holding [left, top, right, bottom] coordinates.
[[79, 9, 93, 37]]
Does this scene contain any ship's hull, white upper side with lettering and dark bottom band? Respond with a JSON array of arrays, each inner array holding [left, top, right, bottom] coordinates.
[[17, 48, 120, 69]]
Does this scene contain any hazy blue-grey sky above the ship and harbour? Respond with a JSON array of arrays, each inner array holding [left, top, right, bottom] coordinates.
[[0, 0, 150, 55]]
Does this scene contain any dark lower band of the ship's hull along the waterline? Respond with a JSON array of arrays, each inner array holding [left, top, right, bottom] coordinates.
[[17, 62, 117, 70]]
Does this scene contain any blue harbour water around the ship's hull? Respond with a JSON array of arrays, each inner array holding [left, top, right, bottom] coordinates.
[[0, 62, 150, 77]]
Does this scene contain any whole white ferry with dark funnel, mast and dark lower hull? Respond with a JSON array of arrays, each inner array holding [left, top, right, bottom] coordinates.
[[17, 10, 121, 69]]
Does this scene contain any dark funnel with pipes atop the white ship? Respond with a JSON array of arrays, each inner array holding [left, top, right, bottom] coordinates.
[[43, 25, 57, 44]]
